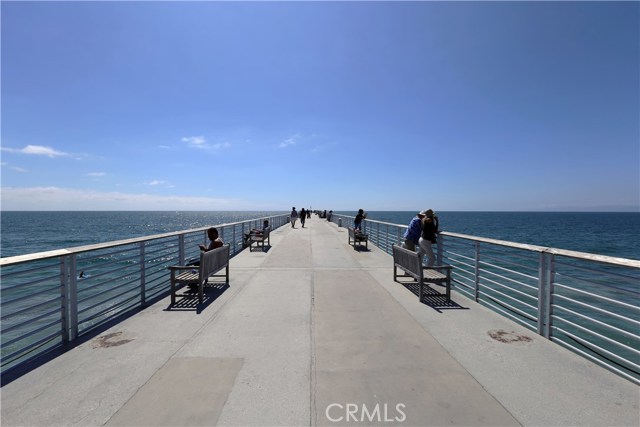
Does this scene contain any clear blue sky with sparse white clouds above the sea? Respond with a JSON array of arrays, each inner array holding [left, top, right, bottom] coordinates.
[[0, 1, 640, 212]]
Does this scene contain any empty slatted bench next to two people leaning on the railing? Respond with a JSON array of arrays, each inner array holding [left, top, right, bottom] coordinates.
[[393, 245, 453, 302]]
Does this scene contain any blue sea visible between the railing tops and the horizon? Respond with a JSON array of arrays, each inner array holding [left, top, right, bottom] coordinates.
[[0, 211, 640, 259]]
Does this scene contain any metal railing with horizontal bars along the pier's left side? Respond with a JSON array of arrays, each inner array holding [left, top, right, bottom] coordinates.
[[0, 215, 289, 373]]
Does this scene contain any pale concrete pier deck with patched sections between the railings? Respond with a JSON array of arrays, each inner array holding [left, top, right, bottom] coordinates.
[[1, 216, 640, 426]]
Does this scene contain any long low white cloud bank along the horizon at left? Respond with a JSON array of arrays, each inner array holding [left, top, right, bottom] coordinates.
[[0, 187, 244, 211]]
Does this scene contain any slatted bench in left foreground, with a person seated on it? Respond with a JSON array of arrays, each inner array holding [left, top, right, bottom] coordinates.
[[168, 244, 229, 305]]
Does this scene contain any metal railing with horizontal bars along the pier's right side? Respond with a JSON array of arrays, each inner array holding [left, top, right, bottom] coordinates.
[[331, 214, 640, 384]]
